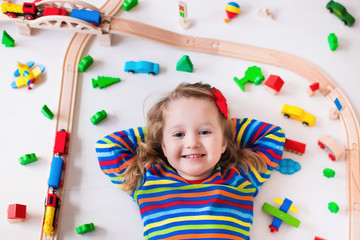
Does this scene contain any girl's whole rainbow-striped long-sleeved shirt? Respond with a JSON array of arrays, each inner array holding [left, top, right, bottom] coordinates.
[[96, 118, 285, 240]]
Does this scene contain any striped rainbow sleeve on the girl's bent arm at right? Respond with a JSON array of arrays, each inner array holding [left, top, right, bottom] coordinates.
[[232, 118, 285, 187]]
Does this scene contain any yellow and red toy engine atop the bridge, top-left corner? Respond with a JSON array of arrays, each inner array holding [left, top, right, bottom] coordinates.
[[1, 2, 40, 20]]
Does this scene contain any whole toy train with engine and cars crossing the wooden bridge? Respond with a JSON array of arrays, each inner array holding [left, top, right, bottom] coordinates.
[[1, 2, 101, 26]]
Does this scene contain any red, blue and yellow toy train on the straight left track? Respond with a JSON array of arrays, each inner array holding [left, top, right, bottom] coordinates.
[[43, 129, 69, 236]]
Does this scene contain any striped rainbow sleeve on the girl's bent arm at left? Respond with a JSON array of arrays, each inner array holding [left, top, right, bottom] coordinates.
[[96, 127, 146, 187]]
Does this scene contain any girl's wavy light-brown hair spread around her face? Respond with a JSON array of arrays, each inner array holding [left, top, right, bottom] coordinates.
[[122, 82, 266, 193]]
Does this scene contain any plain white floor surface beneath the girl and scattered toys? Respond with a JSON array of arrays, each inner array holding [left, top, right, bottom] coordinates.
[[0, 0, 360, 240]]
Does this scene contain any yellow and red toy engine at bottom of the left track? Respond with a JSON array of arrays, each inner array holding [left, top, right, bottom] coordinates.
[[43, 193, 60, 236]]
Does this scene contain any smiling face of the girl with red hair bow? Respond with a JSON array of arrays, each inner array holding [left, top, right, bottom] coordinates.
[[161, 98, 227, 180]]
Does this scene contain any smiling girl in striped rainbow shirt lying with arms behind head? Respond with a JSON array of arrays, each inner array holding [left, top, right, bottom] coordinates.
[[96, 83, 285, 240]]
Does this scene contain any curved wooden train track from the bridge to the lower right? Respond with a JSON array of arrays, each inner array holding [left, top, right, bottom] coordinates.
[[110, 17, 360, 240]]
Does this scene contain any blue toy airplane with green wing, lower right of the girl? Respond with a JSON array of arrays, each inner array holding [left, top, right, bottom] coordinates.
[[262, 198, 300, 232]]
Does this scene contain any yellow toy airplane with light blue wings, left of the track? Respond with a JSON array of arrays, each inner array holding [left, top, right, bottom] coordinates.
[[11, 61, 45, 90]]
